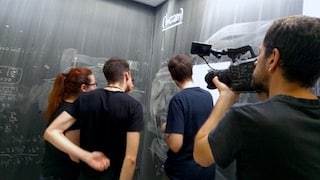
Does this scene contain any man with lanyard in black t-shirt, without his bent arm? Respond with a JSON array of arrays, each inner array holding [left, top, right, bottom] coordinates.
[[70, 58, 143, 179]]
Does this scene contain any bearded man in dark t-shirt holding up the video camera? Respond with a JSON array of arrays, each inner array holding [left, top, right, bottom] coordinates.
[[193, 15, 320, 180]]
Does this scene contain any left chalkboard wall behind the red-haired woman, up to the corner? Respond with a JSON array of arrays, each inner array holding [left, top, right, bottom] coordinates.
[[0, 0, 155, 180]]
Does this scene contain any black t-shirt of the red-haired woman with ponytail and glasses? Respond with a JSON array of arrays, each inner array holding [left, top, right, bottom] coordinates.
[[41, 102, 80, 180]]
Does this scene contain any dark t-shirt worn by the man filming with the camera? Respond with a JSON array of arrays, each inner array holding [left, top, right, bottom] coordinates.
[[208, 95, 320, 180]]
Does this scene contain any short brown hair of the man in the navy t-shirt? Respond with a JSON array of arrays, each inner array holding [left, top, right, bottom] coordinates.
[[168, 54, 193, 82]]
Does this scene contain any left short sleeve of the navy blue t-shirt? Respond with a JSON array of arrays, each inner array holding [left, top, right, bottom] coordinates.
[[165, 97, 184, 134]]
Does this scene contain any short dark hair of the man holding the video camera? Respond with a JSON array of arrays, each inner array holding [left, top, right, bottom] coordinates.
[[263, 15, 320, 87]]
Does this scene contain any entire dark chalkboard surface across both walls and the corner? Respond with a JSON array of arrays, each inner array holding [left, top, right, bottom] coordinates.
[[0, 0, 319, 180]]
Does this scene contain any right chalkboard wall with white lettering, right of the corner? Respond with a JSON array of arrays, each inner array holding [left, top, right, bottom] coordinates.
[[142, 0, 303, 180]]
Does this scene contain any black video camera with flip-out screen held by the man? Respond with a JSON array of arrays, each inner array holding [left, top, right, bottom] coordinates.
[[191, 42, 256, 92]]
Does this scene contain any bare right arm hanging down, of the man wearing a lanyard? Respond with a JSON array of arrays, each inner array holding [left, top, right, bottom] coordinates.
[[120, 132, 140, 180]]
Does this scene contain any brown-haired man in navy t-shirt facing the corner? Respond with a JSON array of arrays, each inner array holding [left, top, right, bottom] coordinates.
[[164, 55, 215, 179]]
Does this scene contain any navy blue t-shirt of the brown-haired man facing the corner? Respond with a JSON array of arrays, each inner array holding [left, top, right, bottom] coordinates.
[[165, 87, 213, 159]]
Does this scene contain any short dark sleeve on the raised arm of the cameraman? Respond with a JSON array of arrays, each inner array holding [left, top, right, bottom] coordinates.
[[208, 108, 243, 168]]
